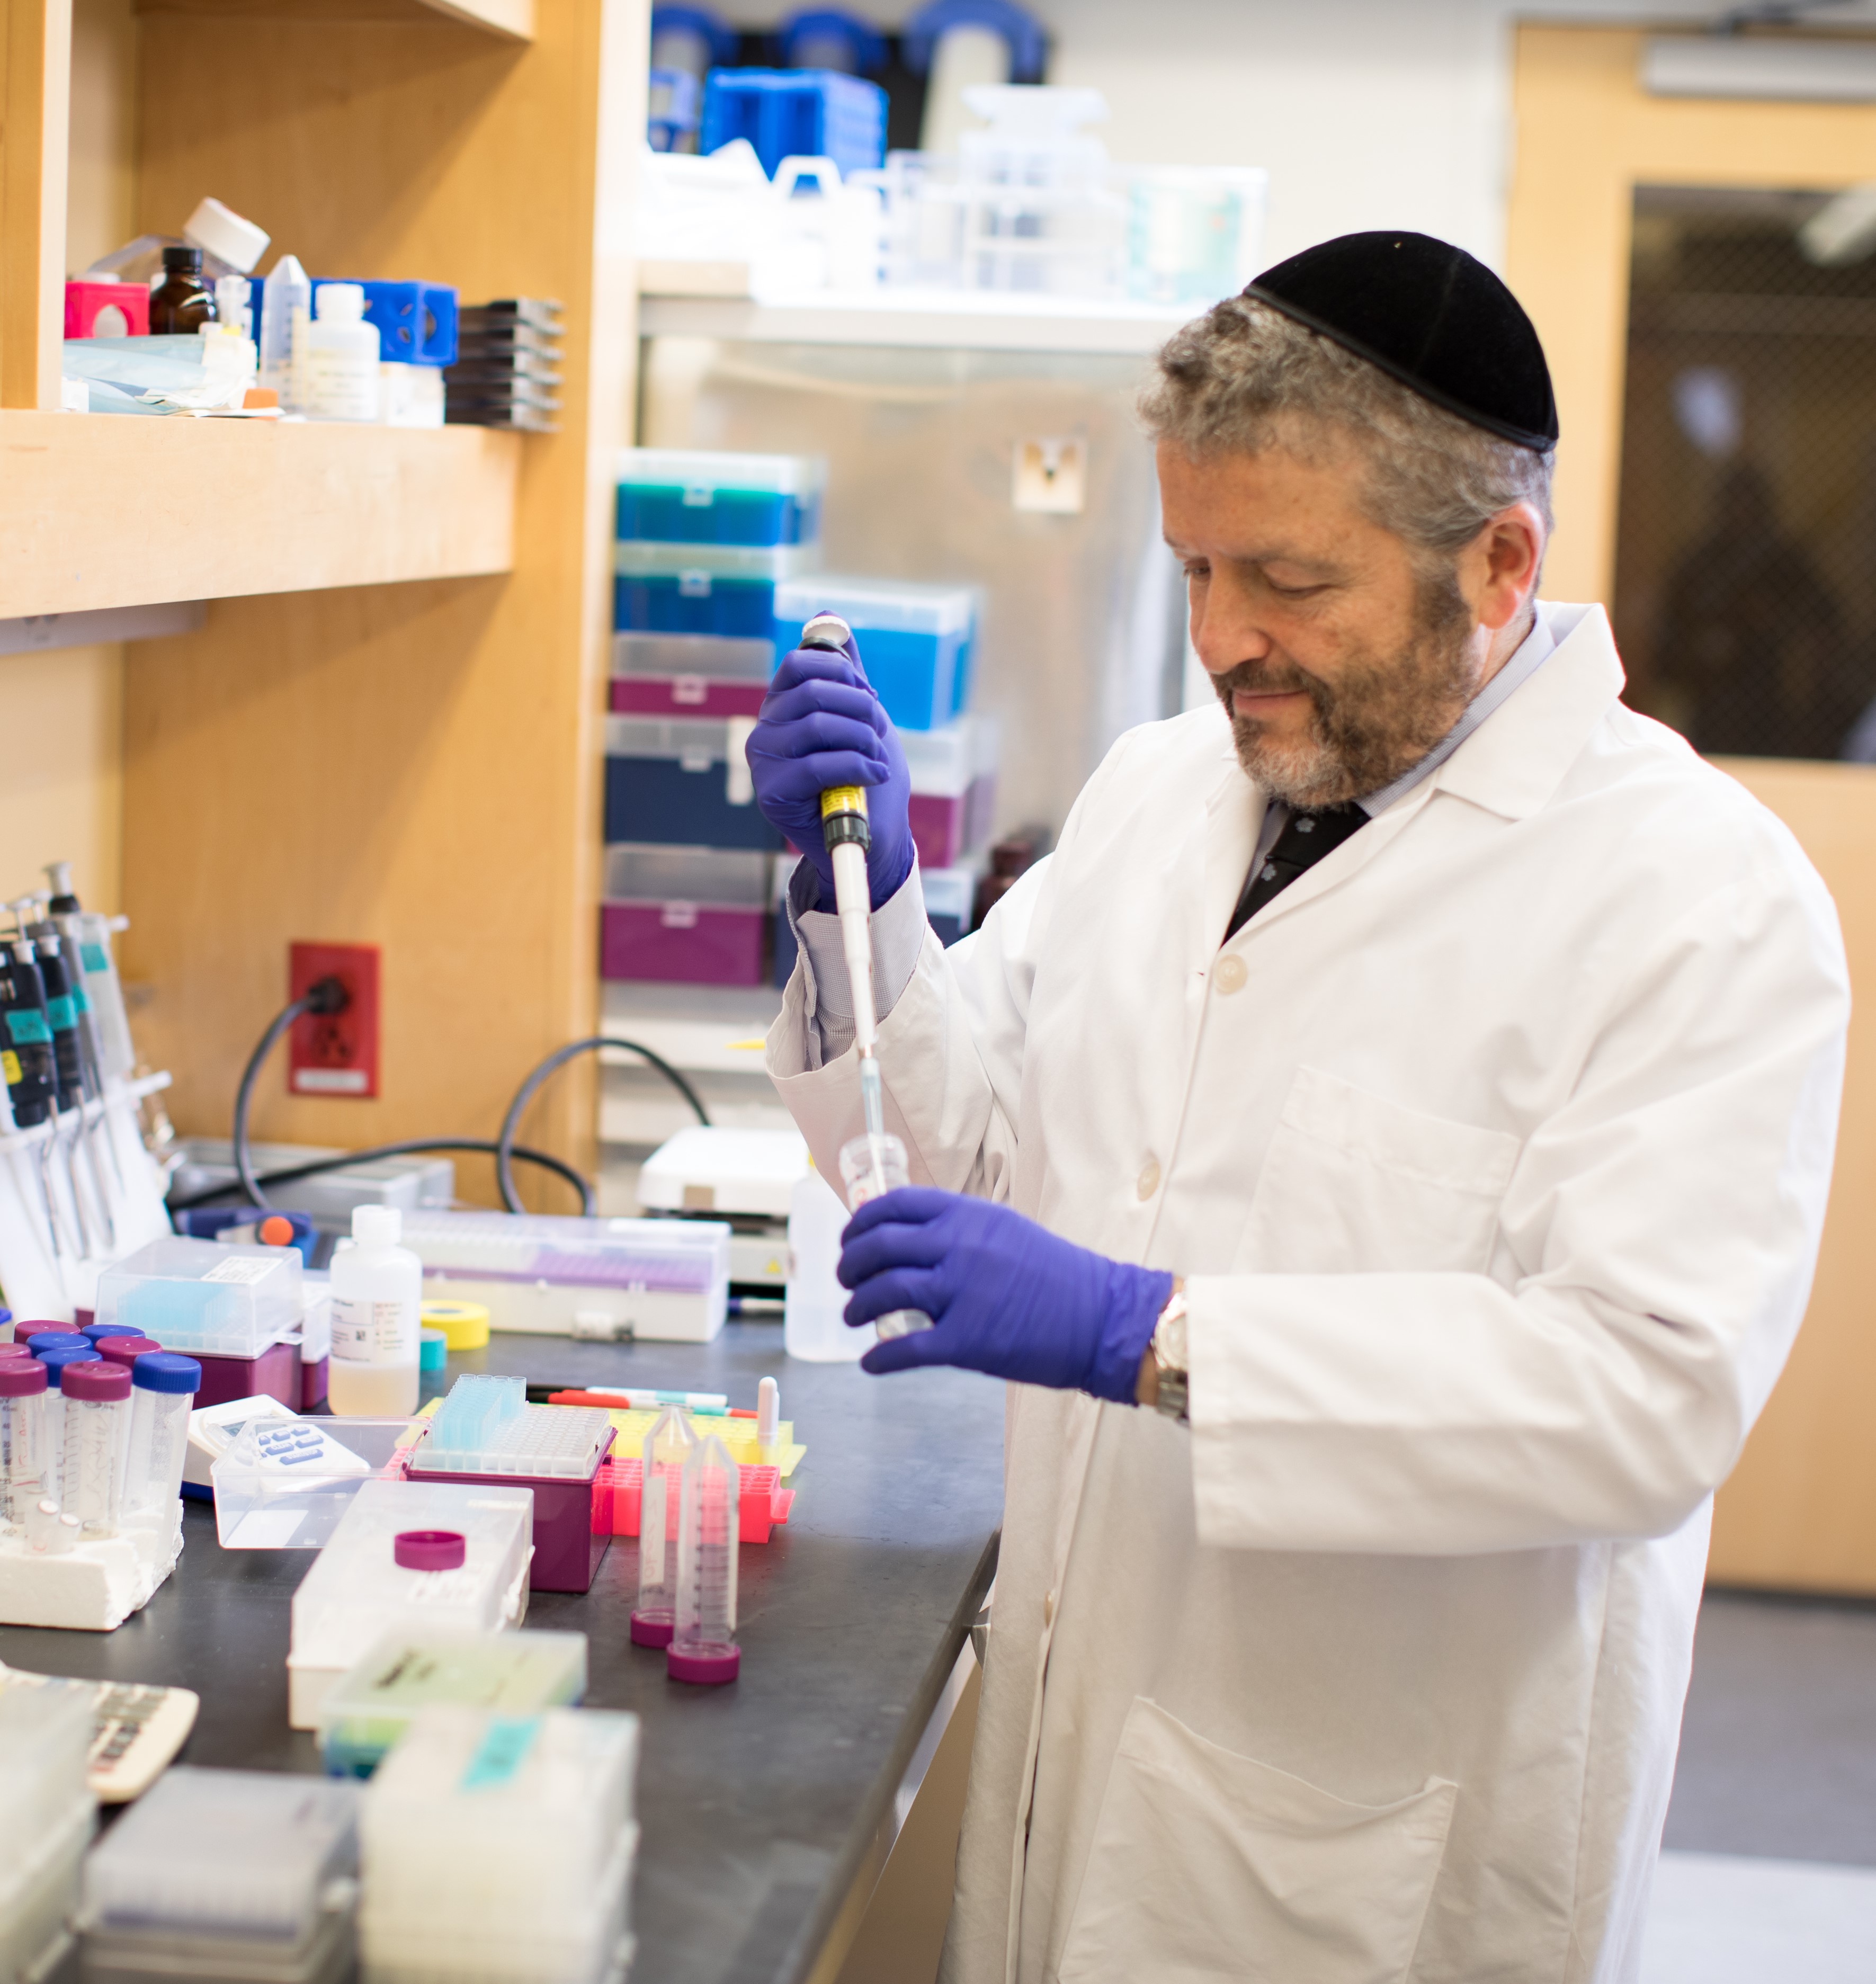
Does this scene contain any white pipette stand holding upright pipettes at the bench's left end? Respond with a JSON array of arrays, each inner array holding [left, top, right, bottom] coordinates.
[[0, 1074, 171, 1325]]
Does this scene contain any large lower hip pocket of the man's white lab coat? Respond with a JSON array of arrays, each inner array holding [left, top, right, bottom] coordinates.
[[1059, 1696, 1458, 1984]]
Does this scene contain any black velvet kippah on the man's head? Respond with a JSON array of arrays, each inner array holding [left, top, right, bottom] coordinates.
[[1244, 234, 1557, 450]]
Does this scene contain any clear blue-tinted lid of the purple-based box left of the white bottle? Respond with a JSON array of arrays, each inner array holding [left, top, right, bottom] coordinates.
[[95, 1234, 303, 1357]]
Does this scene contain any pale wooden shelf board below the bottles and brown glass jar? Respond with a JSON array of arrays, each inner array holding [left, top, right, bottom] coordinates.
[[0, 413, 522, 619]]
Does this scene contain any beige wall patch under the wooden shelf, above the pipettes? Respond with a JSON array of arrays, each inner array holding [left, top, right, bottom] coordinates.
[[0, 645, 123, 910]]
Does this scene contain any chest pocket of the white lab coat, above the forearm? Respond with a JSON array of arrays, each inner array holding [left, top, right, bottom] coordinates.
[[1239, 1067, 1521, 1274]]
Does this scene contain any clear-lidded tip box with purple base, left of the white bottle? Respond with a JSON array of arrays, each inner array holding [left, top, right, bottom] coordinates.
[[97, 1234, 306, 1405]]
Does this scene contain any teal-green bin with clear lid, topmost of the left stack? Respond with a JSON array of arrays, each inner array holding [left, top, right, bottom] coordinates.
[[617, 449, 827, 546]]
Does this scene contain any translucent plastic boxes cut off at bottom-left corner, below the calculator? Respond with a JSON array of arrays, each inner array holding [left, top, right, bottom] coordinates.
[[0, 1681, 97, 1978]]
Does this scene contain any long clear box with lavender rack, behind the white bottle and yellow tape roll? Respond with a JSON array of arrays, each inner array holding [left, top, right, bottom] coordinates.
[[405, 1210, 730, 1343]]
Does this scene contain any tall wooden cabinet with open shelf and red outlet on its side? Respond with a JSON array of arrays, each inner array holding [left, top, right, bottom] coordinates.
[[0, 0, 648, 1204]]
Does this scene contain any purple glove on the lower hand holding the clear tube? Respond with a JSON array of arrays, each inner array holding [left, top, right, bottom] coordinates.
[[841, 1186, 1172, 1405]]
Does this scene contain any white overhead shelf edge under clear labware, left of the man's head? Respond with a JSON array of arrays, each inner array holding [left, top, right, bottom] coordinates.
[[639, 281, 1194, 357]]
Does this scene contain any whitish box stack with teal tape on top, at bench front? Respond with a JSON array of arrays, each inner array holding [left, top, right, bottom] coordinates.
[[359, 1706, 639, 1984]]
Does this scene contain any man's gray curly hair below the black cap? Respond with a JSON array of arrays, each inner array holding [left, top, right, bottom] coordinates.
[[1140, 296, 1555, 558]]
